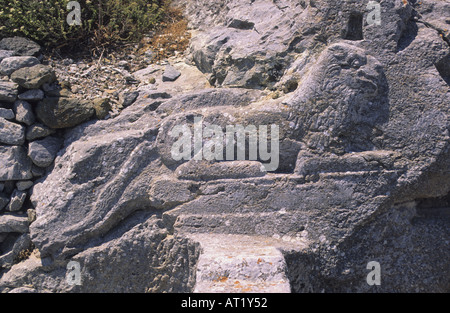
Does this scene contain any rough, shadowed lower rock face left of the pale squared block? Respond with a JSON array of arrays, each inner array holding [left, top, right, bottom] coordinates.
[[0, 214, 200, 293]]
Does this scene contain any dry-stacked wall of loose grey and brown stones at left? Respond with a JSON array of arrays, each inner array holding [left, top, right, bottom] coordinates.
[[0, 37, 110, 268]]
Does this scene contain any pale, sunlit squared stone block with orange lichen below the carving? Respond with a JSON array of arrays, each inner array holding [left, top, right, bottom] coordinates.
[[193, 235, 291, 293]]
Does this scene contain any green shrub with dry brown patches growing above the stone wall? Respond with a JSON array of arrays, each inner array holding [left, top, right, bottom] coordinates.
[[0, 0, 168, 48]]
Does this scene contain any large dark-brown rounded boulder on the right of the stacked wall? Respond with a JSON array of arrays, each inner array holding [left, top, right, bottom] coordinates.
[[36, 97, 95, 128]]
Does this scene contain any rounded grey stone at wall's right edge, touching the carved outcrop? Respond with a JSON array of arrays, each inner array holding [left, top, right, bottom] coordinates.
[[28, 137, 61, 167]]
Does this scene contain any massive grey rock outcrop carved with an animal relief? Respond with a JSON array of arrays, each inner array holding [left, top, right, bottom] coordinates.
[[0, 0, 450, 292]]
